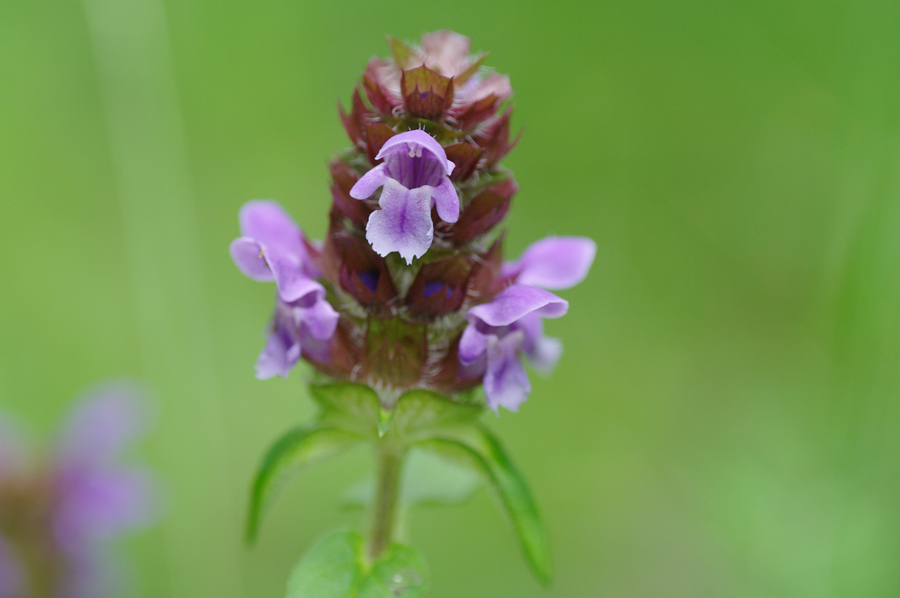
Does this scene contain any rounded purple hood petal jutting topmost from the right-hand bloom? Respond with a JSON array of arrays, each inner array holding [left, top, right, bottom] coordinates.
[[503, 237, 597, 290]]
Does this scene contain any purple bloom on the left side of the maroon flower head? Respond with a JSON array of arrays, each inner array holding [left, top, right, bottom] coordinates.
[[230, 201, 340, 380]]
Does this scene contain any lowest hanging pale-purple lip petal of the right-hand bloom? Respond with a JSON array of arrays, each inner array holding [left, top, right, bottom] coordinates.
[[484, 332, 531, 411]]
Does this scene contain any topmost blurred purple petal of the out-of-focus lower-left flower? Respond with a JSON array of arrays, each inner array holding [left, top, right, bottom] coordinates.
[[57, 383, 148, 468]]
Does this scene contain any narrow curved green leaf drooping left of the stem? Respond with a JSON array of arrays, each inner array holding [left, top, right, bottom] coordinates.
[[247, 424, 362, 542]]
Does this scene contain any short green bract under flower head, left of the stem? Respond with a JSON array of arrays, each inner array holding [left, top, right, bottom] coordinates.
[[309, 382, 380, 438]]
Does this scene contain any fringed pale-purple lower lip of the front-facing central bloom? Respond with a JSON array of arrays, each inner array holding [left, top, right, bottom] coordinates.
[[366, 179, 434, 264]]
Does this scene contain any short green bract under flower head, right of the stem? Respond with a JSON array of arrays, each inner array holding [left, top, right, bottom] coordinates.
[[390, 390, 484, 441]]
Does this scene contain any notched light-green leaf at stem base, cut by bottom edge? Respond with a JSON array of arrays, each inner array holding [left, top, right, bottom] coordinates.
[[287, 531, 425, 598]]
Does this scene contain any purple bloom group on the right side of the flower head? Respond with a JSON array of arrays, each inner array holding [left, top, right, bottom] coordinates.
[[459, 237, 597, 411]]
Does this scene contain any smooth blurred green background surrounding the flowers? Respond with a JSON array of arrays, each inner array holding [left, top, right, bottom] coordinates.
[[0, 0, 900, 598]]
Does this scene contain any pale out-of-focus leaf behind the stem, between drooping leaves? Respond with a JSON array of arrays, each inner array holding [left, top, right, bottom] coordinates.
[[343, 449, 480, 508]]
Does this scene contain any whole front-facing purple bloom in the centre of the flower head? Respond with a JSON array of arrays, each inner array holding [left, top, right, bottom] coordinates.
[[350, 130, 459, 264]]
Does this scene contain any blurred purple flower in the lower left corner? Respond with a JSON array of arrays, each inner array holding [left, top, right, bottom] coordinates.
[[0, 385, 154, 598]]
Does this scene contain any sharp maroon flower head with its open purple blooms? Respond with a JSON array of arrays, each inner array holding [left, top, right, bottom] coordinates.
[[231, 31, 596, 410]]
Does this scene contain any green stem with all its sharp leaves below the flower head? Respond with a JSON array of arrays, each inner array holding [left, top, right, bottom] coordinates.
[[247, 383, 551, 598]]
